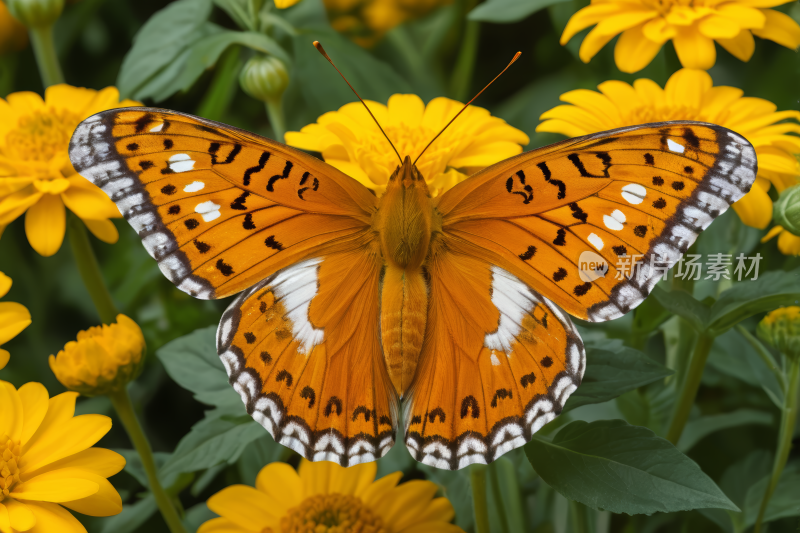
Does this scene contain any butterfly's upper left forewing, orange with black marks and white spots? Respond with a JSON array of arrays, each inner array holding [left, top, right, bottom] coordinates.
[[70, 107, 375, 299]]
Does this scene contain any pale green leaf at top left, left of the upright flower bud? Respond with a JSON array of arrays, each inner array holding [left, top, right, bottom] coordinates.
[[117, 0, 211, 99]]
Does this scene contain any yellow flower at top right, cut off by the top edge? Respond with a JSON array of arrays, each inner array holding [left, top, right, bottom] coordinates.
[[561, 0, 800, 72]]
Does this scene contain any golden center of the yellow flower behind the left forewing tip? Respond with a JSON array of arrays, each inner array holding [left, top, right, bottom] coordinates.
[[5, 109, 80, 161]]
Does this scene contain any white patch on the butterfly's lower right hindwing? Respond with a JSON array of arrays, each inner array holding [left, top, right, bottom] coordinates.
[[483, 266, 533, 354]]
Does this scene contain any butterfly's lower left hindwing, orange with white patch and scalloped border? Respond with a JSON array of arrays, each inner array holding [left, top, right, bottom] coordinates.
[[217, 235, 397, 466]]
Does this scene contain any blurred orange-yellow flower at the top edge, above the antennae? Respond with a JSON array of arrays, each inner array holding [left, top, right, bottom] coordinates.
[[324, 0, 452, 48]]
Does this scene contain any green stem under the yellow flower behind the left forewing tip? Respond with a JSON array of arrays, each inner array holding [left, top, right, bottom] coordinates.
[[67, 214, 119, 324]]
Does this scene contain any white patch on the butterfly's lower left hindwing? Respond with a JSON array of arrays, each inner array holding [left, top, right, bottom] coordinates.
[[271, 259, 325, 353]]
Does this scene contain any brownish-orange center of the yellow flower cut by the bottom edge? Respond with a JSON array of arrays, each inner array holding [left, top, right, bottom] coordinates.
[[276, 494, 386, 533]]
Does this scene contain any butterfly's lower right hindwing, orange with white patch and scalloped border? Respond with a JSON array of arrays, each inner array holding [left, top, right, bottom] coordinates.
[[404, 234, 586, 470]]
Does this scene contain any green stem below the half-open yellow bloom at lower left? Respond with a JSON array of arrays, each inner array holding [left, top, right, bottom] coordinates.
[[109, 387, 186, 533]]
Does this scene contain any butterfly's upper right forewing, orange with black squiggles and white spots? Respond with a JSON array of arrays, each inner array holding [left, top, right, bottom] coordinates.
[[437, 122, 757, 321]]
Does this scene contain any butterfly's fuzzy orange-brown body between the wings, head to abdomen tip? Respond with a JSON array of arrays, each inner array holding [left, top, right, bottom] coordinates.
[[376, 157, 434, 396]]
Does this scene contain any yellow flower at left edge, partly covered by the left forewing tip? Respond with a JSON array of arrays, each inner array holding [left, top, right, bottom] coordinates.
[[0, 85, 139, 256]]
